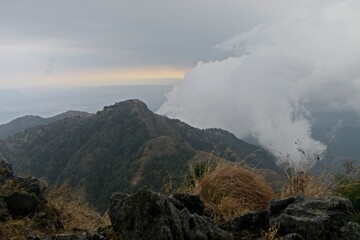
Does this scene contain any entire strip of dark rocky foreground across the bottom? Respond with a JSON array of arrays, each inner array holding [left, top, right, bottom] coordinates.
[[0, 161, 360, 240]]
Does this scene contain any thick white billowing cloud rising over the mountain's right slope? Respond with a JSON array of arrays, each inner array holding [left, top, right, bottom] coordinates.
[[158, 1, 360, 165]]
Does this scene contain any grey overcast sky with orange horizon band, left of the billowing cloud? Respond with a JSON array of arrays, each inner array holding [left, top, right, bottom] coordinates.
[[0, 0, 330, 89]]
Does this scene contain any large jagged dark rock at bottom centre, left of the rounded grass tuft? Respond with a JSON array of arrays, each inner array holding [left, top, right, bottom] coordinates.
[[109, 189, 232, 240]]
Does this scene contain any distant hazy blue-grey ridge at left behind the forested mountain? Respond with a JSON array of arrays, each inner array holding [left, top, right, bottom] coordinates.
[[0, 111, 91, 139]]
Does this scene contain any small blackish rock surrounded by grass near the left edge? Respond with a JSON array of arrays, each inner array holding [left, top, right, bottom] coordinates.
[[4, 192, 40, 217]]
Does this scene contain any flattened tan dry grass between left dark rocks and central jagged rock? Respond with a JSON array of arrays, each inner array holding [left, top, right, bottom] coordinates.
[[48, 183, 111, 233]]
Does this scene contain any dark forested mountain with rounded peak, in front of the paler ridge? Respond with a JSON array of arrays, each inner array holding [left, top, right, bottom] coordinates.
[[0, 100, 277, 209]]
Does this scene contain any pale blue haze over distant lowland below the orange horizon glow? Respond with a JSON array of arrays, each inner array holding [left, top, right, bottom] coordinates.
[[0, 85, 171, 124]]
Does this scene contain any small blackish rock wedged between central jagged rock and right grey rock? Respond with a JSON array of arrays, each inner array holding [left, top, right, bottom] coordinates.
[[218, 210, 269, 239]]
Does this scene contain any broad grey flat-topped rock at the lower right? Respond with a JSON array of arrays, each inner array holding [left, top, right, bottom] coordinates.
[[269, 196, 353, 240]]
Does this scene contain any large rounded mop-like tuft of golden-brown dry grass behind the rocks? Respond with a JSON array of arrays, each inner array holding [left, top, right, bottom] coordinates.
[[198, 162, 275, 220]]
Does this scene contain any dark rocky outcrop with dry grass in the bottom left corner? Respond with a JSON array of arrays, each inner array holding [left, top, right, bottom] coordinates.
[[0, 160, 63, 240]]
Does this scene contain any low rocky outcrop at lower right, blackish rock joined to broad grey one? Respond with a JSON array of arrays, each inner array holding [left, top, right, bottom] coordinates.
[[220, 196, 360, 240]]
